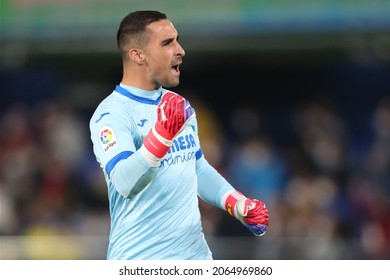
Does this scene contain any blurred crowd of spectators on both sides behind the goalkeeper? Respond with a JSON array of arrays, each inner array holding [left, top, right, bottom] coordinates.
[[0, 76, 390, 259]]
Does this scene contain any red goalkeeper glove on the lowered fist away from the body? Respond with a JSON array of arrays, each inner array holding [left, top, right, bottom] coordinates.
[[224, 191, 268, 236]]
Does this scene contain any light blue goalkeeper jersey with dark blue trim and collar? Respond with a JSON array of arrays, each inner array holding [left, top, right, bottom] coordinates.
[[90, 85, 233, 260]]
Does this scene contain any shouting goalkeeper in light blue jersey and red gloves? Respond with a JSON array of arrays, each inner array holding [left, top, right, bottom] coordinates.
[[90, 11, 268, 260]]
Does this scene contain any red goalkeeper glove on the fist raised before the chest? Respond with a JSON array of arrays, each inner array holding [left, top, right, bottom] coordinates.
[[141, 92, 195, 161]]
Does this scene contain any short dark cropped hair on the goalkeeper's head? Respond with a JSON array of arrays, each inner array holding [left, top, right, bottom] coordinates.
[[116, 10, 167, 56]]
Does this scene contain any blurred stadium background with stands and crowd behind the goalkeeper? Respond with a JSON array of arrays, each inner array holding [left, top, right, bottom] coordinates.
[[0, 0, 390, 259]]
